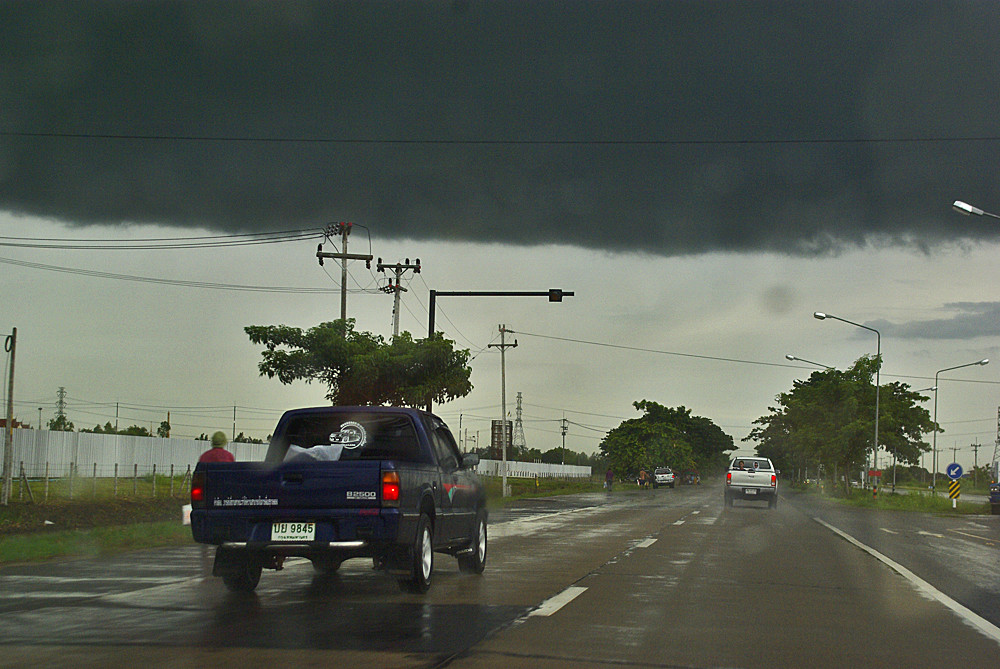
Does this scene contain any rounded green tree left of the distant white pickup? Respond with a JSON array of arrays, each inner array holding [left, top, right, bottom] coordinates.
[[600, 400, 733, 476]]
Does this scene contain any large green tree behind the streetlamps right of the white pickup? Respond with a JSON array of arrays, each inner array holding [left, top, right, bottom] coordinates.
[[744, 356, 935, 490]]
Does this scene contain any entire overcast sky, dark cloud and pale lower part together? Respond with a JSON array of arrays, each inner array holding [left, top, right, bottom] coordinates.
[[0, 0, 1000, 472]]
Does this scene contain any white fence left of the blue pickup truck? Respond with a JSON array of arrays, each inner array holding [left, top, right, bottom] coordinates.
[[0, 428, 267, 478]]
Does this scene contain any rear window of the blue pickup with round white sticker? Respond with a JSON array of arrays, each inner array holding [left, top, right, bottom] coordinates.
[[265, 413, 420, 462]]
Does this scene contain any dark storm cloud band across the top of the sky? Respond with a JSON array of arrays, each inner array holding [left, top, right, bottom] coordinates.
[[0, 0, 1000, 254]]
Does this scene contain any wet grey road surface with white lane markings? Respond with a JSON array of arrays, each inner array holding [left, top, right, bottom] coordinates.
[[0, 485, 1000, 667]]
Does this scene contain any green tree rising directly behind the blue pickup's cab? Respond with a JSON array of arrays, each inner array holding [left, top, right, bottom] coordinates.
[[244, 318, 472, 406]]
